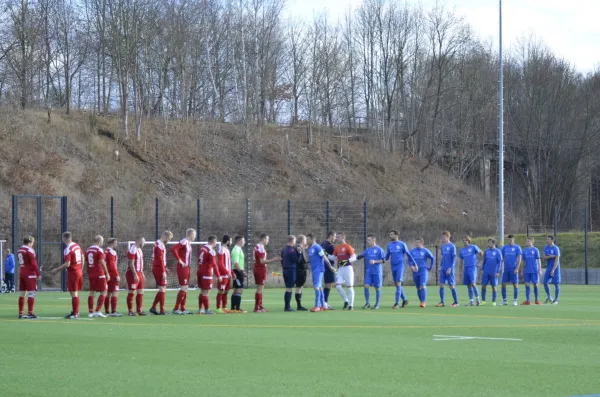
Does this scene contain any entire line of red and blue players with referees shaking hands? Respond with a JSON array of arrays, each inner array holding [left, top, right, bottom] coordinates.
[[11, 229, 560, 319]]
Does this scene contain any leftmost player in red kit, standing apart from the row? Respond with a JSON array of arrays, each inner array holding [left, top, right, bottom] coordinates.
[[17, 236, 41, 319]]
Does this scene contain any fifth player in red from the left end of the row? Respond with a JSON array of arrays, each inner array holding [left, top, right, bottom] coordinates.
[[125, 236, 147, 317]]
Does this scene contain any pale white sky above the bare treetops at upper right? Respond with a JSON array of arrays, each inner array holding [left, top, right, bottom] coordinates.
[[286, 0, 600, 73]]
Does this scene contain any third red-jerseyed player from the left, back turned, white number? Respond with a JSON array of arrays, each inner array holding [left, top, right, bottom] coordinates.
[[84, 236, 110, 317]]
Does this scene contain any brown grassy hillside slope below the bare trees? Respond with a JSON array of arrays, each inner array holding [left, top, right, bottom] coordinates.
[[0, 109, 519, 244]]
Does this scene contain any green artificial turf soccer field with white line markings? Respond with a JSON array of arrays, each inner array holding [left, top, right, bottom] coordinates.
[[0, 286, 600, 397]]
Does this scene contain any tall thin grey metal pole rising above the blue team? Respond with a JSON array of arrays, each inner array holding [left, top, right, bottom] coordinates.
[[498, 0, 504, 246]]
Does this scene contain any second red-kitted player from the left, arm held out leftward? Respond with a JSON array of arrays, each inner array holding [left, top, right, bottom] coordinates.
[[52, 232, 83, 319]]
